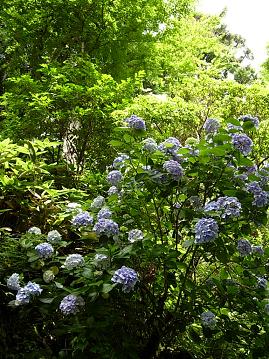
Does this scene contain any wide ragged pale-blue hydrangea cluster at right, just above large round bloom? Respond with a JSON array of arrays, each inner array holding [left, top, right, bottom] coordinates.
[[204, 196, 242, 219]]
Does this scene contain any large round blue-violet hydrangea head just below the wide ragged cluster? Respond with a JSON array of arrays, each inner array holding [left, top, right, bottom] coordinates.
[[195, 218, 219, 244]]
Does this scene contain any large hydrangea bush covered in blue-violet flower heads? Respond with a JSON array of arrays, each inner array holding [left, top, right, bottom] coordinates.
[[2, 115, 269, 358]]
